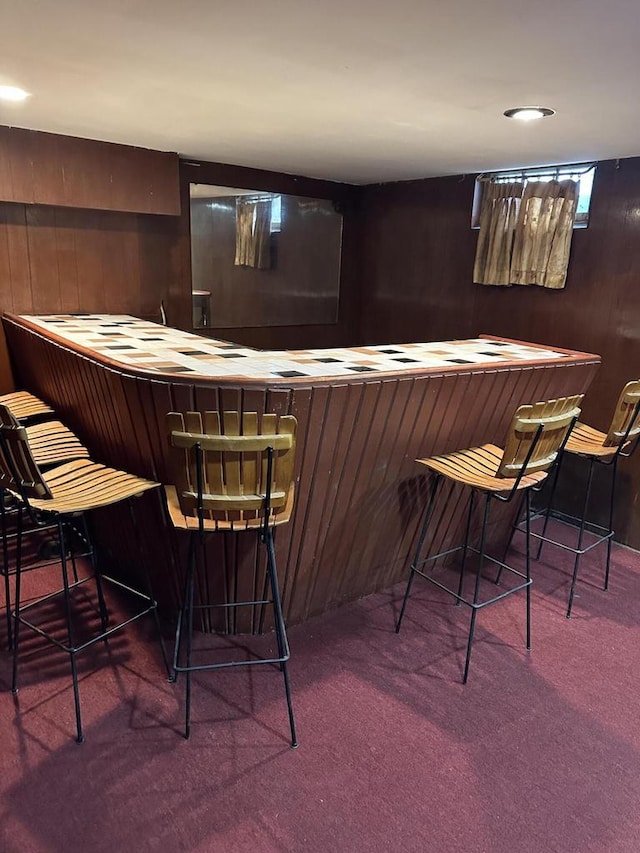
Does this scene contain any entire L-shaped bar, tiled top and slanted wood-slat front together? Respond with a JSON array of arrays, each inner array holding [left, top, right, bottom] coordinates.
[[3, 315, 600, 632]]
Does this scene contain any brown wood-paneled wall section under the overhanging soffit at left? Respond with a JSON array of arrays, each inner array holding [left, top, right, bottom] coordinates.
[[0, 202, 179, 391]]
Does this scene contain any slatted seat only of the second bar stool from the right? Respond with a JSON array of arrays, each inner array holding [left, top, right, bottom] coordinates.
[[417, 444, 547, 492]]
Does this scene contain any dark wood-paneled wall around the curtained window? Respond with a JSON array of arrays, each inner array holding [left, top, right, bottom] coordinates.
[[361, 158, 640, 547]]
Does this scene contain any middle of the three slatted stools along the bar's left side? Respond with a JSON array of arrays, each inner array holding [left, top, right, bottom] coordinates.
[[0, 412, 89, 648]]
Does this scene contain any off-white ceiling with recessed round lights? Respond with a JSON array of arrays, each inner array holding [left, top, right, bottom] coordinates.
[[0, 0, 640, 183]]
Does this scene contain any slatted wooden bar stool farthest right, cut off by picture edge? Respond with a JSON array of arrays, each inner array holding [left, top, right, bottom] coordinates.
[[518, 379, 640, 619]]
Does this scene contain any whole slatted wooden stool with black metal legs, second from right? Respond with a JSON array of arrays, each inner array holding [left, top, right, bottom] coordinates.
[[396, 396, 582, 684]]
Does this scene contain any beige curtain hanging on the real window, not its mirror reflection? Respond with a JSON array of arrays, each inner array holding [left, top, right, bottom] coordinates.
[[473, 180, 578, 288]]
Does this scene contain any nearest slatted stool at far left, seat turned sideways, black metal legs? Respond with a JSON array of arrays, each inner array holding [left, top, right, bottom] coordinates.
[[0, 405, 169, 743]]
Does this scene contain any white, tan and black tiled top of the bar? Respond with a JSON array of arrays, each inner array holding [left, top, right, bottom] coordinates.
[[22, 314, 586, 381]]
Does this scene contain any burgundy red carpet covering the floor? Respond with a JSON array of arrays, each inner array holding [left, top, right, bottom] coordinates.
[[0, 520, 640, 853]]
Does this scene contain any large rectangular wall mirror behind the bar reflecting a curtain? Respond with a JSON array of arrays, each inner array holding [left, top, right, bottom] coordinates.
[[189, 184, 342, 329]]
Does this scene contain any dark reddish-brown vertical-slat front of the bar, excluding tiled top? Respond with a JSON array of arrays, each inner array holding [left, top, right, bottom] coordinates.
[[6, 321, 596, 631]]
